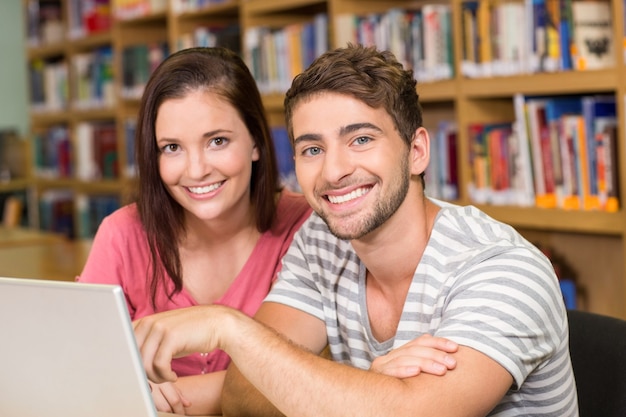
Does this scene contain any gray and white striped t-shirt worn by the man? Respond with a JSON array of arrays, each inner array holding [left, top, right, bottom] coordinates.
[[266, 201, 578, 417]]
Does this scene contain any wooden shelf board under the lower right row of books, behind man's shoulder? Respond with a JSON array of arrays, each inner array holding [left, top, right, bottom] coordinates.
[[477, 205, 625, 235]]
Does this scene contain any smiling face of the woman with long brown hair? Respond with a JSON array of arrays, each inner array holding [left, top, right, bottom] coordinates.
[[155, 91, 259, 221]]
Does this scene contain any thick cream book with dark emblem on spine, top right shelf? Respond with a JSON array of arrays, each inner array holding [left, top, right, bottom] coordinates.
[[572, 0, 615, 70]]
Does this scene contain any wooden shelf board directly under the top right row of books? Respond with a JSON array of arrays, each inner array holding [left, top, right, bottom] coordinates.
[[460, 69, 619, 98]]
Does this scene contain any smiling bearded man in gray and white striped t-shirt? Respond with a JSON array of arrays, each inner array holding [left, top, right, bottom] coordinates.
[[135, 46, 578, 417]]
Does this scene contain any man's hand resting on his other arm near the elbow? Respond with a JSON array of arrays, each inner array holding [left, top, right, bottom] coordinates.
[[370, 334, 458, 378]]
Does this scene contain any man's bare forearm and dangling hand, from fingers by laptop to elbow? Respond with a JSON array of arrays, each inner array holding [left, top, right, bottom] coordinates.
[[135, 306, 513, 417]]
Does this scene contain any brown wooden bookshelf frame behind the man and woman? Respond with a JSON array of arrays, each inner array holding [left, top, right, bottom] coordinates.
[[24, 0, 626, 318]]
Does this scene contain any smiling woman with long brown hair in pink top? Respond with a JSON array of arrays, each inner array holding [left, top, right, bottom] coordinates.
[[77, 48, 311, 414]]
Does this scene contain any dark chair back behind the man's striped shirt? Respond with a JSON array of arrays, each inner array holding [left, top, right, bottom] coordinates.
[[567, 310, 626, 417]]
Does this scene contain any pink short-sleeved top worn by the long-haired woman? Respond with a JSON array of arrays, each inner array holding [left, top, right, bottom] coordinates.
[[76, 191, 311, 376]]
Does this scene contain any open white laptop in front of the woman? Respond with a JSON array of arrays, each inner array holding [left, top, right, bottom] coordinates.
[[0, 278, 173, 417]]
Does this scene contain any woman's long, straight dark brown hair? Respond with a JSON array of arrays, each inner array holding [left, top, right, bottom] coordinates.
[[135, 47, 280, 309]]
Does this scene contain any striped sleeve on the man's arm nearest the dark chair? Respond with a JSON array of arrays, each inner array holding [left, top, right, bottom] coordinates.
[[436, 248, 567, 387]]
